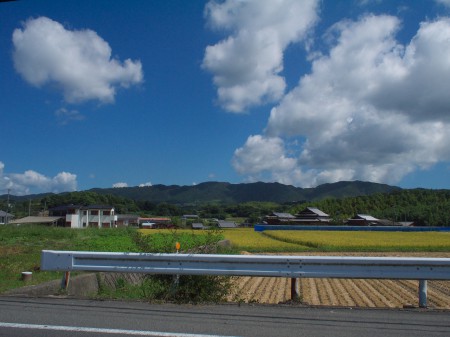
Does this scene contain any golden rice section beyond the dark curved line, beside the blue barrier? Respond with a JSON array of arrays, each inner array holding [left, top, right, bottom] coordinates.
[[264, 230, 450, 251]]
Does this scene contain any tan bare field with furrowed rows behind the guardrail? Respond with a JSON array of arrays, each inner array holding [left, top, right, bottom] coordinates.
[[229, 253, 450, 309]]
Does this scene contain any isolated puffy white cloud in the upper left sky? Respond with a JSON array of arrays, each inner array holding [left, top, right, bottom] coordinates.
[[12, 17, 143, 103]]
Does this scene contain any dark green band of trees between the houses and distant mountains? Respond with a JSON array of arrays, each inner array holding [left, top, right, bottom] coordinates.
[[0, 189, 450, 226]]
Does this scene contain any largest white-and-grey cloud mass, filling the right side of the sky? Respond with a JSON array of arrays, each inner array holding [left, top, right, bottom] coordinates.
[[234, 15, 450, 187]]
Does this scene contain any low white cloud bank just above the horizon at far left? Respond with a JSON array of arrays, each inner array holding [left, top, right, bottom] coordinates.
[[0, 162, 77, 195]]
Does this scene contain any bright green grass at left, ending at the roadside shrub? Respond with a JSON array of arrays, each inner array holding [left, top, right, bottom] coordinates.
[[0, 225, 139, 293]]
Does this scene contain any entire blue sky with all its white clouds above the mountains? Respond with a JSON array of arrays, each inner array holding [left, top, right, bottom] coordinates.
[[0, 0, 450, 195]]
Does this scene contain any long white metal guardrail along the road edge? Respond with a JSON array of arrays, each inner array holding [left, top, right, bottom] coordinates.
[[41, 250, 450, 307]]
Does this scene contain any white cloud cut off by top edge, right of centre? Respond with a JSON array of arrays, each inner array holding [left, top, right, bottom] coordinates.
[[203, 0, 318, 113]]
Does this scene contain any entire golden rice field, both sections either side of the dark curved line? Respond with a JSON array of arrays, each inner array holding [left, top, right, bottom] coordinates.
[[214, 228, 450, 253]]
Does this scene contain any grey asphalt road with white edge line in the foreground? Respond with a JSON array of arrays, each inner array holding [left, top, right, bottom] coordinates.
[[0, 297, 450, 337]]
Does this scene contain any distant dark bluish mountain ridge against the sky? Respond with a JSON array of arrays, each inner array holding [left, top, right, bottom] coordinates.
[[85, 181, 401, 204]]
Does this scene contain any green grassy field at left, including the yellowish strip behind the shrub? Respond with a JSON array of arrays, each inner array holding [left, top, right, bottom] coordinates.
[[0, 225, 222, 293]]
